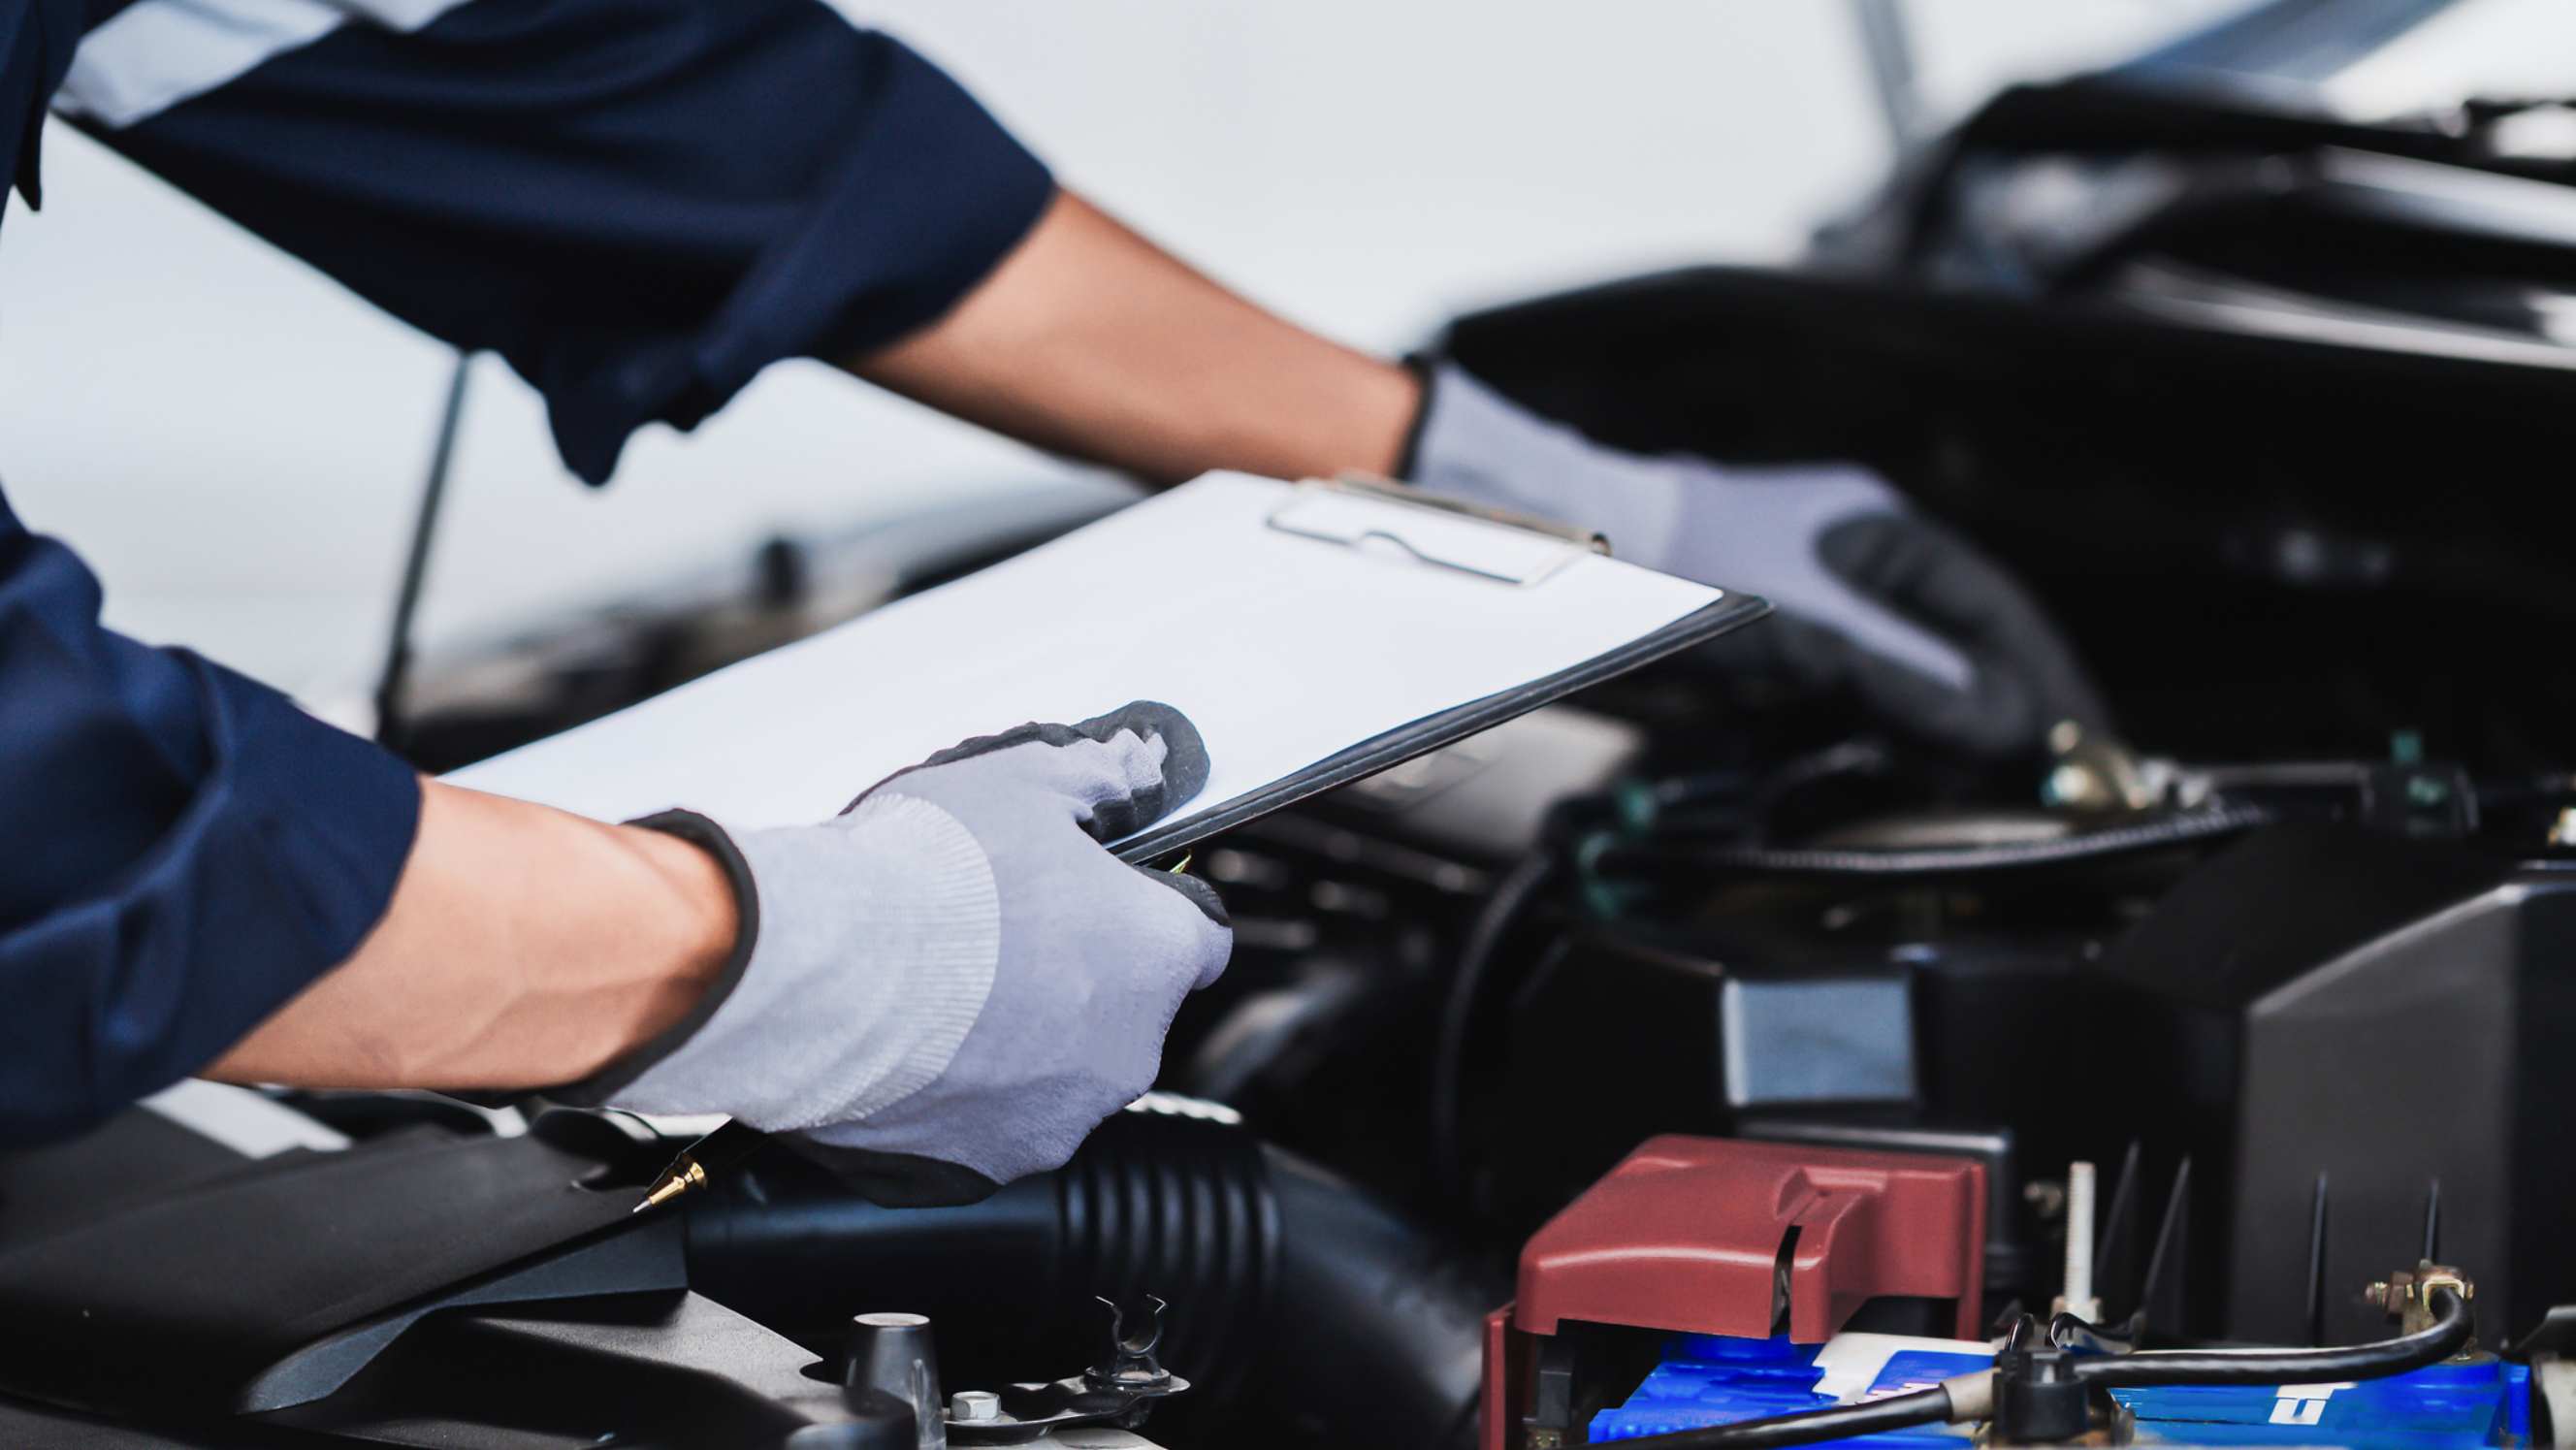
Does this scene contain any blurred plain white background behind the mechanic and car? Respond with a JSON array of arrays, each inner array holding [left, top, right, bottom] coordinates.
[[0, 0, 2307, 700]]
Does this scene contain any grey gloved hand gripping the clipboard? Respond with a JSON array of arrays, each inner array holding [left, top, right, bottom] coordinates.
[[582, 703, 1234, 1206]]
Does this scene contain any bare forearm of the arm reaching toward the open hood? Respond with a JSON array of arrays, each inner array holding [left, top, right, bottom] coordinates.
[[845, 191, 1419, 482]]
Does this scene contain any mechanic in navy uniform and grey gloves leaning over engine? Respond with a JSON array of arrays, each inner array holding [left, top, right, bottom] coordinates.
[[0, 0, 2094, 1198]]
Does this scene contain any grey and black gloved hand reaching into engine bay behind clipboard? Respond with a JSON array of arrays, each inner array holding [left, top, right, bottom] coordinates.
[[1409, 366, 2108, 757]]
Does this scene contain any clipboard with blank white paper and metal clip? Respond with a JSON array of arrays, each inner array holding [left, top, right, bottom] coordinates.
[[448, 474, 1770, 863]]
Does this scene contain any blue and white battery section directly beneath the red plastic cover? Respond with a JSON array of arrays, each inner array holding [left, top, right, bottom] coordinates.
[[1590, 1335, 1988, 1450]]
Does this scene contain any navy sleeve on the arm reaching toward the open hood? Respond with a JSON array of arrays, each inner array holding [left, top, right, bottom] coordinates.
[[82, 0, 1053, 484]]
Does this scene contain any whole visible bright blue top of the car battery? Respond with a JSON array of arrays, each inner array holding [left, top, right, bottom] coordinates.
[[1590, 1335, 2532, 1450]]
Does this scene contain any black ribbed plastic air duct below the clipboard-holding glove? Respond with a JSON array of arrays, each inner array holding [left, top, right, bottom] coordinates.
[[688, 1110, 1504, 1450]]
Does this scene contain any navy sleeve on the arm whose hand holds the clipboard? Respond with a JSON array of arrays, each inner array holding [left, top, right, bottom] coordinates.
[[0, 486, 420, 1144]]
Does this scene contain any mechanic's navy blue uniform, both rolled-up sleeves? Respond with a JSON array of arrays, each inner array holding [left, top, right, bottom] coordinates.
[[0, 0, 1051, 1144]]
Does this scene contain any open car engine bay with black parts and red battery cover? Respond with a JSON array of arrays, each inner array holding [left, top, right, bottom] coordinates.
[[0, 45, 2576, 1450]]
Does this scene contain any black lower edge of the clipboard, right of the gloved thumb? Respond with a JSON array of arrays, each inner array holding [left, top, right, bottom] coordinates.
[[1115, 595, 1770, 865]]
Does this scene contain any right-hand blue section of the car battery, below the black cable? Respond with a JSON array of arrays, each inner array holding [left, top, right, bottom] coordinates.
[[2112, 1357, 2532, 1450]]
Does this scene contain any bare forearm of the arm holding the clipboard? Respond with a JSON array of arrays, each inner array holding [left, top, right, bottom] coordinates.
[[206, 781, 734, 1089]]
